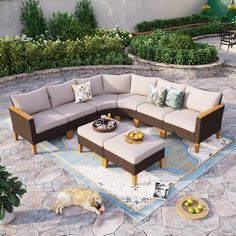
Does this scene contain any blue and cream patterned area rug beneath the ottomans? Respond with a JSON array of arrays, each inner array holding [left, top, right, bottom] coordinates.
[[1, 120, 236, 221]]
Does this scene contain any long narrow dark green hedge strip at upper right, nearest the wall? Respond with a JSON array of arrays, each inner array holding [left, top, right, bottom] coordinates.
[[135, 14, 225, 32]]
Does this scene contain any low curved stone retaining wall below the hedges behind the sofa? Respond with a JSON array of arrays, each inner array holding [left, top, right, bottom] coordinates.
[[0, 58, 223, 88]]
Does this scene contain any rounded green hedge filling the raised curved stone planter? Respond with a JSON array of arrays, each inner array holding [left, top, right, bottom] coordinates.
[[130, 31, 217, 65]]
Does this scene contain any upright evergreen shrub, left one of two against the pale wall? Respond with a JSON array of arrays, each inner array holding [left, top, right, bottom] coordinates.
[[20, 0, 46, 38]]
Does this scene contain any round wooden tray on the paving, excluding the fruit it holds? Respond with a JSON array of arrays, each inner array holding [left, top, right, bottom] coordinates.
[[175, 196, 209, 220]]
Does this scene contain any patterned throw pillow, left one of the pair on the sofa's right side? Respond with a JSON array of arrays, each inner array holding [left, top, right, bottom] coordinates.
[[146, 85, 167, 107]]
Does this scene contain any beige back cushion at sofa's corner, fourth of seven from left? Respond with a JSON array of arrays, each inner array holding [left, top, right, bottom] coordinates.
[[102, 74, 131, 94]]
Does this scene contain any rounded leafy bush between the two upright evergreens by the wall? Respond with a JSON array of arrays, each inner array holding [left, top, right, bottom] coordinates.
[[48, 12, 94, 41]]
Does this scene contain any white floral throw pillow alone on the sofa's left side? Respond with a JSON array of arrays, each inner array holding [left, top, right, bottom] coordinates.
[[72, 81, 93, 103]]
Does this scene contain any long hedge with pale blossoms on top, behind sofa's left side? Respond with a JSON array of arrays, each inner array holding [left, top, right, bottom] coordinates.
[[0, 35, 129, 77]]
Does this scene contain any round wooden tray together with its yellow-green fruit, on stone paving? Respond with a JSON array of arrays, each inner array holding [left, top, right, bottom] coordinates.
[[176, 196, 209, 220]]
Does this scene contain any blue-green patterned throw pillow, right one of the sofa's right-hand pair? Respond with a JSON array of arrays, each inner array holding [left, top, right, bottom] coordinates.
[[165, 87, 184, 109]]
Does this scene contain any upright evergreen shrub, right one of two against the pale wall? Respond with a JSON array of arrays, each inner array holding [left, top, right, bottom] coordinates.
[[75, 0, 97, 29]]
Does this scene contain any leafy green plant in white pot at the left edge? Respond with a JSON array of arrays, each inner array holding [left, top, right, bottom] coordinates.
[[0, 165, 26, 224]]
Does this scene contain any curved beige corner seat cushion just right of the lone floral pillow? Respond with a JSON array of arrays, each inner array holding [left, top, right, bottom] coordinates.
[[87, 94, 117, 111]]
